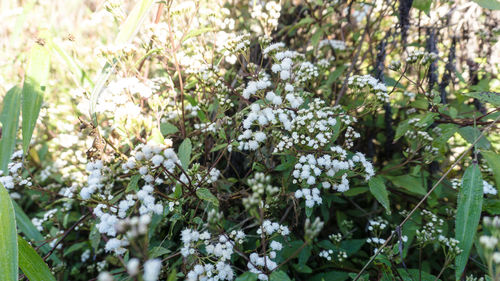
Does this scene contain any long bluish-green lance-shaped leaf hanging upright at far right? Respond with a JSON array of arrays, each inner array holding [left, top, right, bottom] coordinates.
[[455, 163, 483, 280]]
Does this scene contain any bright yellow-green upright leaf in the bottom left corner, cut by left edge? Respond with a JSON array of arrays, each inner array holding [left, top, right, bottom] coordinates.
[[0, 183, 18, 281]]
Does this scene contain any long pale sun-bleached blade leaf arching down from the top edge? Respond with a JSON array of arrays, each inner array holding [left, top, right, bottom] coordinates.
[[90, 0, 154, 122]]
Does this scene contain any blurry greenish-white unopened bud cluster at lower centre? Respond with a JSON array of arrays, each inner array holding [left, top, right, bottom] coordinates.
[[242, 173, 280, 209]]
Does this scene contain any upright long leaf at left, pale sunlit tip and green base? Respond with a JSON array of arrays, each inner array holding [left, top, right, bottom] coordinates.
[[22, 40, 50, 154]]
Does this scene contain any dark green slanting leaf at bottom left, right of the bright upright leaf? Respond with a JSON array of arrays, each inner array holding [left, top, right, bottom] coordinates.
[[17, 236, 56, 281]]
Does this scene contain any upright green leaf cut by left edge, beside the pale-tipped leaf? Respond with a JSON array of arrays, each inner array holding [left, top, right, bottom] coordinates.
[[0, 86, 21, 175]]
